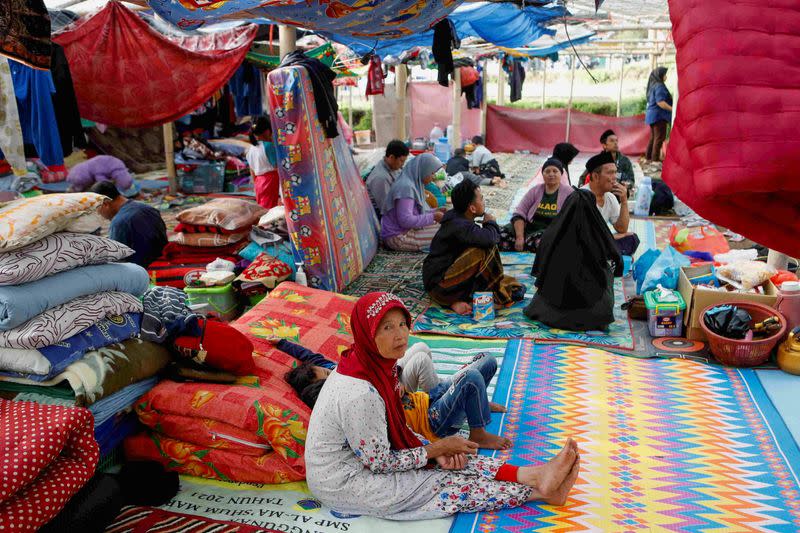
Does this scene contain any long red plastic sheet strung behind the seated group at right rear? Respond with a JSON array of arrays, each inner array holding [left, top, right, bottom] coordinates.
[[486, 105, 650, 156]]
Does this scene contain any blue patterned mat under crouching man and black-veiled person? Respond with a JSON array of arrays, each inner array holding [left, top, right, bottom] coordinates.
[[413, 253, 635, 351]]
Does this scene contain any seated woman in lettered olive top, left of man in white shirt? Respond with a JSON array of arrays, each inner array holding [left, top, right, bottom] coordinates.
[[500, 157, 573, 252]]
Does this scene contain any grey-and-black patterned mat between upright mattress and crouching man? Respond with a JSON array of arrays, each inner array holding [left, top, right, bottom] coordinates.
[[342, 249, 430, 317]]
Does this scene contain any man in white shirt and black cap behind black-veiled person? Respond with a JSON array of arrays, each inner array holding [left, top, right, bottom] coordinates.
[[583, 152, 639, 255]]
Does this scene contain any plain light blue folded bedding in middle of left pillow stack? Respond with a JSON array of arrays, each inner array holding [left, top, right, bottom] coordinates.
[[0, 263, 150, 331]]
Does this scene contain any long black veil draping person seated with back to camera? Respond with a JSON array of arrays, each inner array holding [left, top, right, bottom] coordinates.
[[531, 188, 622, 310]]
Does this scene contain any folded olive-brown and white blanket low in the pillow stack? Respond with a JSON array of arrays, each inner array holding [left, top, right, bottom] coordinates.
[[2, 339, 170, 406]]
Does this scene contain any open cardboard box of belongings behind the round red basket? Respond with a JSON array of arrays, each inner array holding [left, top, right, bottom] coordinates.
[[678, 265, 778, 341]]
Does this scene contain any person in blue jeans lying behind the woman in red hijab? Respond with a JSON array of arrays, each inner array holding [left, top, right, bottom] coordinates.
[[275, 340, 511, 450]]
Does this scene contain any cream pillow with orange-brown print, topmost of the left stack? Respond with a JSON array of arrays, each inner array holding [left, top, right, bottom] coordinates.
[[0, 192, 105, 252]]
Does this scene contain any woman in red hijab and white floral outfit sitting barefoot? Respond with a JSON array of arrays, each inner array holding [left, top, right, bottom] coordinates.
[[305, 292, 580, 520]]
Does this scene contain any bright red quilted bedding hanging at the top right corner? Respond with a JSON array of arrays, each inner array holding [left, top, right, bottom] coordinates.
[[663, 0, 800, 257]]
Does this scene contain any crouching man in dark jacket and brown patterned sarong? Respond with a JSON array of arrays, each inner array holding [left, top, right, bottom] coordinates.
[[422, 180, 525, 315]]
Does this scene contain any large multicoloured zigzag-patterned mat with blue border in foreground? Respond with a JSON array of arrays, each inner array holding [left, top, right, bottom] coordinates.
[[451, 341, 800, 533]]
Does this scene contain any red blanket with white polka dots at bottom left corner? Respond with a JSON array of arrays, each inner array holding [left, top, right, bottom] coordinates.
[[0, 399, 99, 531]]
